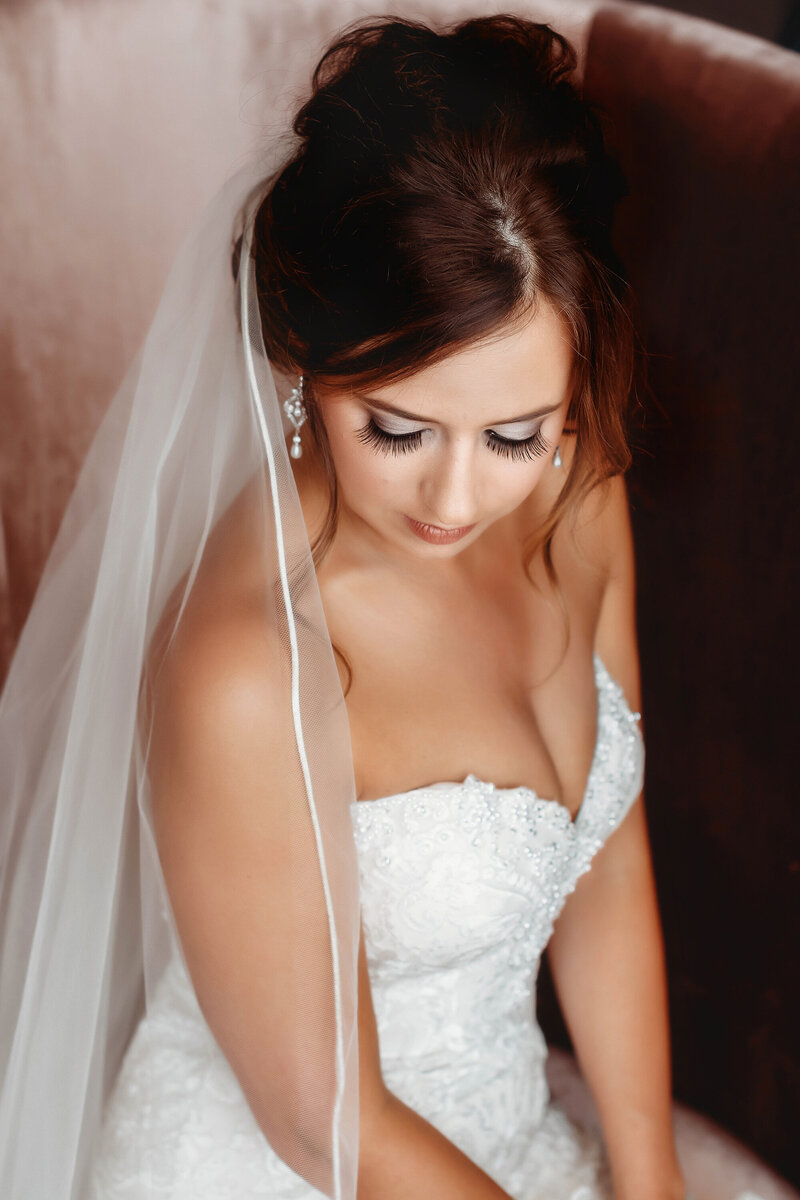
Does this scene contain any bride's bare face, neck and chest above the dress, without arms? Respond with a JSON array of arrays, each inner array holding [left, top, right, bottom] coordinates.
[[295, 297, 607, 814]]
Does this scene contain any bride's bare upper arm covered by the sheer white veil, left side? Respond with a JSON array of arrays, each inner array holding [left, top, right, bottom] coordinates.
[[148, 604, 335, 1187]]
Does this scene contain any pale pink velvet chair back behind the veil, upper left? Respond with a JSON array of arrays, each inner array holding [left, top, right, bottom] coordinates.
[[0, 0, 596, 679]]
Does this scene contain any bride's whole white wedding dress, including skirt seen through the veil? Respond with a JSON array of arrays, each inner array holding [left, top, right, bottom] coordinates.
[[81, 655, 762, 1200]]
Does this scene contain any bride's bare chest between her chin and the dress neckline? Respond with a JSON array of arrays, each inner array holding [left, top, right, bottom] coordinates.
[[323, 528, 602, 812]]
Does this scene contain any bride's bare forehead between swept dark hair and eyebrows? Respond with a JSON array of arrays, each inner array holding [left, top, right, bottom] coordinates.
[[350, 299, 575, 427]]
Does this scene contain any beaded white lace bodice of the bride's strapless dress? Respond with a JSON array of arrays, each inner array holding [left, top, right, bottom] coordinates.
[[354, 656, 644, 1200]]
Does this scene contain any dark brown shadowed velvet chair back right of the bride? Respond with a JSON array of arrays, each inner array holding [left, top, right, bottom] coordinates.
[[575, 5, 800, 1183]]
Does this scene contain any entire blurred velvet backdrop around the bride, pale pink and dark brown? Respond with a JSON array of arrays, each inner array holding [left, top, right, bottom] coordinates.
[[0, 0, 800, 1184]]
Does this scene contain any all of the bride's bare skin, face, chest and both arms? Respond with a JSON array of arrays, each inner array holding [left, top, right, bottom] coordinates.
[[151, 302, 682, 1200]]
